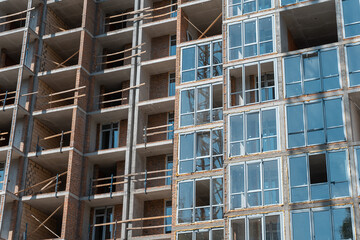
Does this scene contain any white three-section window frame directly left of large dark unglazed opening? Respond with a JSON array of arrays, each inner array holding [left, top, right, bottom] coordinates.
[[226, 15, 276, 61]]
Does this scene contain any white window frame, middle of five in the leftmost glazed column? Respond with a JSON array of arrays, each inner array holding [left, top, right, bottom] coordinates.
[[177, 128, 224, 174]]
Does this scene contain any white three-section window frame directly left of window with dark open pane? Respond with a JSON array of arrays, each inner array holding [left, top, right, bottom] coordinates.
[[228, 158, 283, 210]]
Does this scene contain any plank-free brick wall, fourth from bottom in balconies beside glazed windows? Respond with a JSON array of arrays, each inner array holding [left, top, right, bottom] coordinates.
[[149, 73, 169, 99]]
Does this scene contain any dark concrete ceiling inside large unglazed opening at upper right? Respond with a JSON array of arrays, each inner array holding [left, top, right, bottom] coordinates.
[[281, 1, 337, 49]]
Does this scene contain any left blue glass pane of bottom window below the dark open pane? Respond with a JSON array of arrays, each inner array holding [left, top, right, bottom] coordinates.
[[292, 212, 311, 240]]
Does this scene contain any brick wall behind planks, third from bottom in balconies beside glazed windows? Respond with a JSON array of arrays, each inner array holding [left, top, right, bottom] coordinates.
[[147, 113, 168, 142]]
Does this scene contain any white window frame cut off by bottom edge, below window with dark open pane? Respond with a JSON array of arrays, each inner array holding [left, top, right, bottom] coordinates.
[[290, 205, 356, 240]]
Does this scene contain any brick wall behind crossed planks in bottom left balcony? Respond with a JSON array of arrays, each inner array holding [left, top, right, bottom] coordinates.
[[20, 203, 62, 240]]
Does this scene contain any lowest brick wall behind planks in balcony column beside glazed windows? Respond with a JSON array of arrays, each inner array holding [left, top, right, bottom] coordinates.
[[143, 199, 165, 235]]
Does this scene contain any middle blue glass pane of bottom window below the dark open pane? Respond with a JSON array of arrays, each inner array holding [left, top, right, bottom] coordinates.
[[313, 210, 332, 240]]
